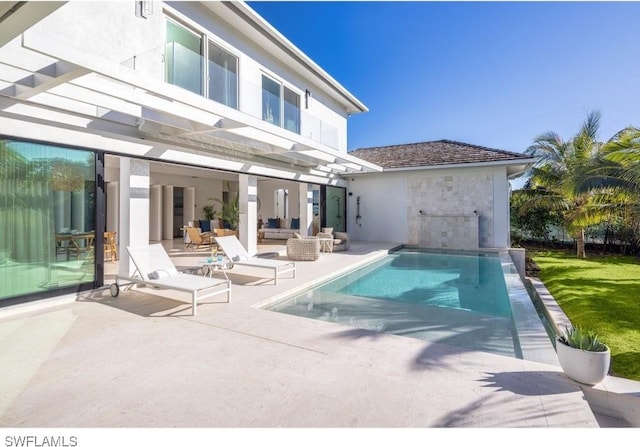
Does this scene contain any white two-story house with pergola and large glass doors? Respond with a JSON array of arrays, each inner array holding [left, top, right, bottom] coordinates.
[[0, 1, 381, 304]]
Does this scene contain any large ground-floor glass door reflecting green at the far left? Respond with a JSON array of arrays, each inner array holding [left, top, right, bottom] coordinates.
[[0, 138, 96, 300]]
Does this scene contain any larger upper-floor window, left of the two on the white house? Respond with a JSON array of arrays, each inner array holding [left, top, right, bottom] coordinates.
[[165, 20, 238, 109]]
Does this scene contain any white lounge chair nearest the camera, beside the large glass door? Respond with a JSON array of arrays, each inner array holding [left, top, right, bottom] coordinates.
[[110, 244, 231, 316]]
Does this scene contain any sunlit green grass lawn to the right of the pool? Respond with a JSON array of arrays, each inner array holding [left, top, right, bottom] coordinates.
[[529, 250, 640, 380]]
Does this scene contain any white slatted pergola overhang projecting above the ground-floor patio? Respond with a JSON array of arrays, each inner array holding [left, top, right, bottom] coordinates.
[[0, 21, 382, 184]]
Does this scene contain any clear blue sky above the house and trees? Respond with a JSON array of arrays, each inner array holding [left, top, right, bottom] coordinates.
[[249, 1, 640, 165]]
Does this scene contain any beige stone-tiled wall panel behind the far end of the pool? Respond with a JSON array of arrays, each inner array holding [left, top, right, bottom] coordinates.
[[407, 173, 494, 250]]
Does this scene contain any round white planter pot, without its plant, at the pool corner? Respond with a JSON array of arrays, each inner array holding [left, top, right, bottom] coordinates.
[[556, 340, 611, 385]]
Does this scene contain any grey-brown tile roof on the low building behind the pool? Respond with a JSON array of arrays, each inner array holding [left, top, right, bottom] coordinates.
[[349, 140, 531, 169]]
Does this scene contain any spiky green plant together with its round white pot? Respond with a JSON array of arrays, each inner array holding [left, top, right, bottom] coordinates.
[[556, 326, 611, 385]]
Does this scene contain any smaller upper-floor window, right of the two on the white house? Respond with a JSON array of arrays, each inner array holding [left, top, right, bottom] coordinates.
[[262, 75, 300, 133]]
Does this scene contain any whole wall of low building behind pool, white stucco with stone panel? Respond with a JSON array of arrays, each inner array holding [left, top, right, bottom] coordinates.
[[347, 166, 509, 249]]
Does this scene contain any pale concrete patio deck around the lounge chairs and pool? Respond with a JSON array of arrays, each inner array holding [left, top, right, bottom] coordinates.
[[0, 242, 632, 428]]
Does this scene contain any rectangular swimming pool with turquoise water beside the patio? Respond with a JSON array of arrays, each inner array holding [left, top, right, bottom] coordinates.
[[264, 248, 551, 358]]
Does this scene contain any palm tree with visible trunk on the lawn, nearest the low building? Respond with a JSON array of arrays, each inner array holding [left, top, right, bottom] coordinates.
[[526, 111, 605, 257]]
